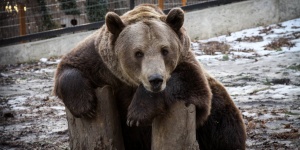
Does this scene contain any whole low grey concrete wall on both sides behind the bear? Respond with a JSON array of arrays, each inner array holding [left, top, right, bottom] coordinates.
[[0, 0, 300, 64]]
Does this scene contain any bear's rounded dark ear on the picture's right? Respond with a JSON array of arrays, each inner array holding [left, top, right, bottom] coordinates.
[[166, 8, 184, 32]]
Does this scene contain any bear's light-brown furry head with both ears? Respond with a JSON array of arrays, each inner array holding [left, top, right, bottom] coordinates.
[[106, 8, 184, 92]]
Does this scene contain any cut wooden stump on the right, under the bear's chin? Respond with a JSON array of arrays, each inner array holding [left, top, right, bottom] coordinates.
[[151, 102, 199, 150]]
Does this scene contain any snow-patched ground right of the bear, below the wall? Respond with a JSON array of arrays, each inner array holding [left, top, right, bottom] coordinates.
[[192, 18, 300, 150]]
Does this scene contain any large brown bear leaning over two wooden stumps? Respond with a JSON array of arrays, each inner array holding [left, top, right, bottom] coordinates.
[[54, 4, 246, 150]]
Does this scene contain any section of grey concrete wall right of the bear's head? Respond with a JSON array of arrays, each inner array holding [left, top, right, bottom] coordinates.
[[184, 0, 300, 39]]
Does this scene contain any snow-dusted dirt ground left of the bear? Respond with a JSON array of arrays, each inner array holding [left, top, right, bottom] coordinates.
[[0, 59, 68, 149]]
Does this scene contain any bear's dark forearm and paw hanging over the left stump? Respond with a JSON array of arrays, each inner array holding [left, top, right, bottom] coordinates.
[[54, 68, 97, 118]]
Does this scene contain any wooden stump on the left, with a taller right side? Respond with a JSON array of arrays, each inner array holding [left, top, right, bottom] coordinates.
[[66, 86, 124, 150]]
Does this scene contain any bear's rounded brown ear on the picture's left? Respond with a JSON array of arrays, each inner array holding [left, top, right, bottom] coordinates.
[[105, 12, 125, 36]]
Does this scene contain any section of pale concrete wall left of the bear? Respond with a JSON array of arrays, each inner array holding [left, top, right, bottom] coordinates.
[[0, 31, 94, 64]]
